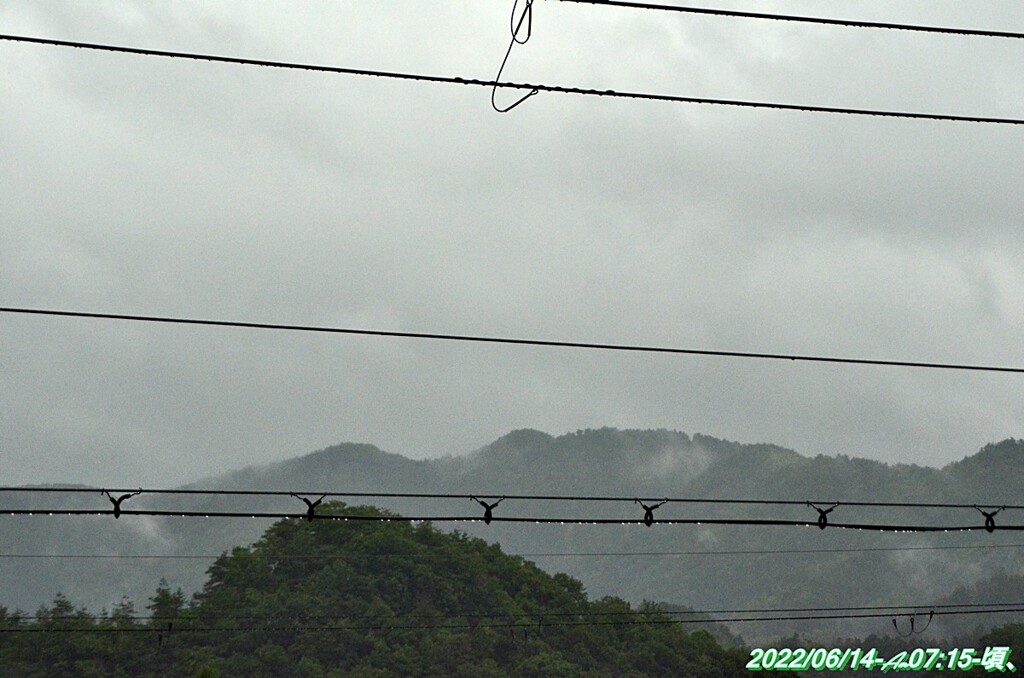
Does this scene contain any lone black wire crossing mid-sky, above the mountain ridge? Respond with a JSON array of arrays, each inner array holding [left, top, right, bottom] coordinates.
[[0, 309, 1024, 374]]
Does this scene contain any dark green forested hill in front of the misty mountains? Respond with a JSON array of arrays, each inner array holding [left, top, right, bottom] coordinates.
[[0, 503, 746, 678]]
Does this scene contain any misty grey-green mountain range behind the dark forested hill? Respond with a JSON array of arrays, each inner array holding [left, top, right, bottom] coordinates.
[[0, 428, 1024, 639]]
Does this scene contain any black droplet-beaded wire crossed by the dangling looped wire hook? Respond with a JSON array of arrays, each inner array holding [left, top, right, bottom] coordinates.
[[0, 34, 1024, 125]]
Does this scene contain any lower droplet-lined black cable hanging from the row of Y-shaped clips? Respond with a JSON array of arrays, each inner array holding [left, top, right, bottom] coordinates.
[[0, 508, 1024, 533]]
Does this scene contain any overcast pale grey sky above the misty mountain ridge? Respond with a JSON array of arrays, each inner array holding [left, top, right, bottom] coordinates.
[[0, 0, 1024, 485]]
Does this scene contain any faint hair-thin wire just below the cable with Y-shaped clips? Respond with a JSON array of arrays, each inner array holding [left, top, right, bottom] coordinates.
[[0, 544, 1024, 560]]
